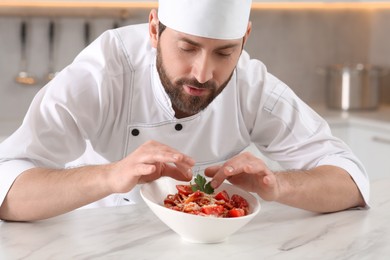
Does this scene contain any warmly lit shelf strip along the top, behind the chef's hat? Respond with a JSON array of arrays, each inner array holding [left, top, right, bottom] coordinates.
[[0, 0, 390, 18]]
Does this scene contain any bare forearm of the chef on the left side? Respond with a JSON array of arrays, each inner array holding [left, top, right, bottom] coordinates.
[[0, 166, 111, 221]]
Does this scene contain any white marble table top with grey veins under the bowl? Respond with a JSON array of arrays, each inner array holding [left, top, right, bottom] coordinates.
[[0, 179, 390, 260]]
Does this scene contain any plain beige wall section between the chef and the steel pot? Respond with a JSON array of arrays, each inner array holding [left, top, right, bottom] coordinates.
[[248, 10, 370, 103]]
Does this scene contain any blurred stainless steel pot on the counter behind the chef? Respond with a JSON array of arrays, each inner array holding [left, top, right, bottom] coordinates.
[[326, 64, 386, 110]]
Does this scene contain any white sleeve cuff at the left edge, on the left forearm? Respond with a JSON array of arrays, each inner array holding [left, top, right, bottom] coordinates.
[[0, 160, 35, 205]]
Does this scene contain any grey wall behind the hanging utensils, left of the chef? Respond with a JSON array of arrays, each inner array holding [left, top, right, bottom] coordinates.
[[0, 10, 149, 133]]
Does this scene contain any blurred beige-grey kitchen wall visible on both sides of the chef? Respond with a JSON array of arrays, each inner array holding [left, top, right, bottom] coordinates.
[[0, 9, 390, 134]]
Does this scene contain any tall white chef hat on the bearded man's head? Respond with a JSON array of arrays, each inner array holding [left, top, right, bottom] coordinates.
[[158, 0, 252, 40]]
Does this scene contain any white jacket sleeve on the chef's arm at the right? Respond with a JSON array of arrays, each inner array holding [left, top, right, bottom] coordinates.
[[244, 68, 370, 204]]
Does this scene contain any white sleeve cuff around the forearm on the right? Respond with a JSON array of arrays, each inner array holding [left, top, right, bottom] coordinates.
[[318, 157, 370, 209]]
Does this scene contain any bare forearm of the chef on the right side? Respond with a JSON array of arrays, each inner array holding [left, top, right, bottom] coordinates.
[[277, 166, 365, 213]]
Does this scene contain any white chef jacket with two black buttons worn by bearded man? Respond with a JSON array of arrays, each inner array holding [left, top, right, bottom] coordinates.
[[0, 24, 369, 209]]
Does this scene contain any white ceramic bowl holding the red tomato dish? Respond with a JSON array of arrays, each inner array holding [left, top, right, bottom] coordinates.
[[140, 177, 260, 243]]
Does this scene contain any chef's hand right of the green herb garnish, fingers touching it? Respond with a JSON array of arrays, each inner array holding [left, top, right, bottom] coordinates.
[[205, 152, 279, 201]]
